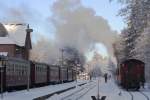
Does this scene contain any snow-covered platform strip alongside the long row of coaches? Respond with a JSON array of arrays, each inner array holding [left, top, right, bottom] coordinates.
[[0, 80, 87, 100]]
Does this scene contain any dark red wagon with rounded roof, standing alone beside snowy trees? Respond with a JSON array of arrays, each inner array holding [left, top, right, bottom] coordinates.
[[117, 59, 145, 90]]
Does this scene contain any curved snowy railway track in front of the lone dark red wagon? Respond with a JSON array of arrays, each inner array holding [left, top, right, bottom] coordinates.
[[128, 91, 150, 100]]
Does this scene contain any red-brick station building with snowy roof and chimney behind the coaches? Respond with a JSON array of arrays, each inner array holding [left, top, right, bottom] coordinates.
[[0, 23, 33, 60]]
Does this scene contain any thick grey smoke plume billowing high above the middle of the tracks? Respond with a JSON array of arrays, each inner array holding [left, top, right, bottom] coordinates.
[[49, 0, 117, 55]]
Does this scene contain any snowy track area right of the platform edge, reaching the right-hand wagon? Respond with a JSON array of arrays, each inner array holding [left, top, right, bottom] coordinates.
[[48, 78, 150, 100]]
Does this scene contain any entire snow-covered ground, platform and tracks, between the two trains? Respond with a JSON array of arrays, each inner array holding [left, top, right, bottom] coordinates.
[[0, 78, 150, 100]]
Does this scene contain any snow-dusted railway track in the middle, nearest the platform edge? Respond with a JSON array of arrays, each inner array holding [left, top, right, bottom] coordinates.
[[61, 83, 96, 100]]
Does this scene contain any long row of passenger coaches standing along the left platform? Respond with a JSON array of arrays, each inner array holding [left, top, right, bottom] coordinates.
[[0, 57, 76, 91]]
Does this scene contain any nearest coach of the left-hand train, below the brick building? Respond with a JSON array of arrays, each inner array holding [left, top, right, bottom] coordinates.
[[0, 57, 30, 90]]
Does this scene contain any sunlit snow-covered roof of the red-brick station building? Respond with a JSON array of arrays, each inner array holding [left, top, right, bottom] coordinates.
[[0, 25, 27, 46]]
